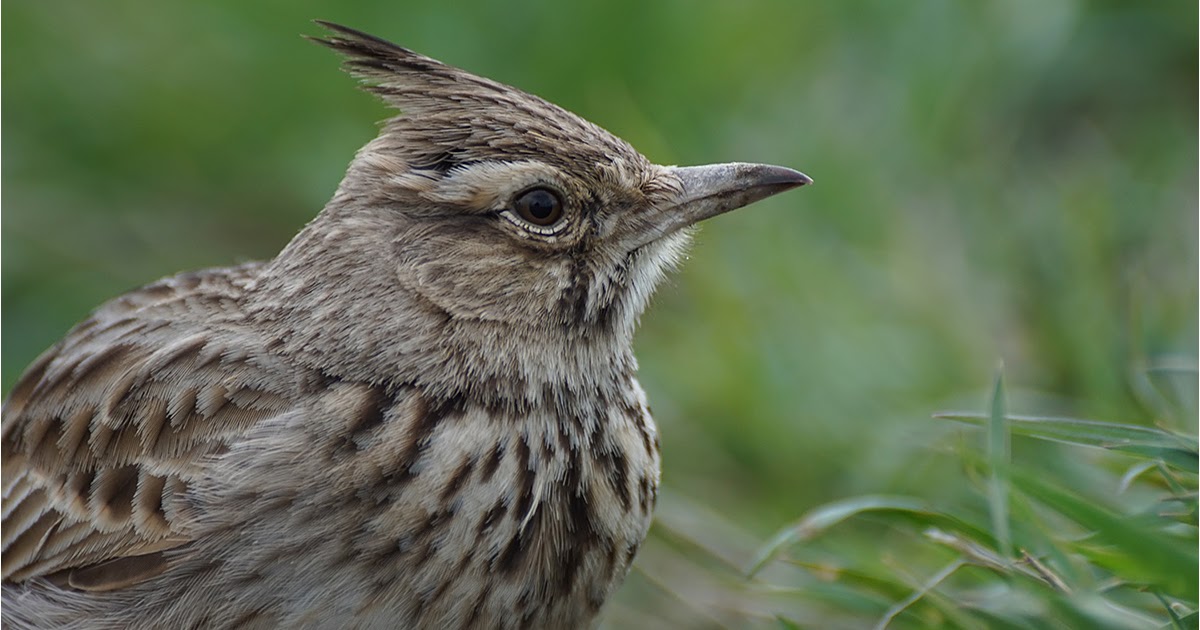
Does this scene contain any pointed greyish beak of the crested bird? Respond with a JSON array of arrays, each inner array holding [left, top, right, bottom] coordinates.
[[643, 162, 812, 244]]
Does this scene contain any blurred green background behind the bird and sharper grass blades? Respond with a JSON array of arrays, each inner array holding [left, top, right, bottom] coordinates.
[[0, 0, 1198, 628]]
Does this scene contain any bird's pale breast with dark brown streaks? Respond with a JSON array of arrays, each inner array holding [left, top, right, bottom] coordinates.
[[200, 378, 659, 628]]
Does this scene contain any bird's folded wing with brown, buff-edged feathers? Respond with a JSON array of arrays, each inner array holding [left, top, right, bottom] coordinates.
[[0, 264, 301, 590]]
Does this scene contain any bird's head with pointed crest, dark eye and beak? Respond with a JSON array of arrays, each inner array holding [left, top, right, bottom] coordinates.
[[259, 23, 810, 384]]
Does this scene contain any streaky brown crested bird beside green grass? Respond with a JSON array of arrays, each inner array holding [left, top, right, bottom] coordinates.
[[2, 20, 811, 629]]
